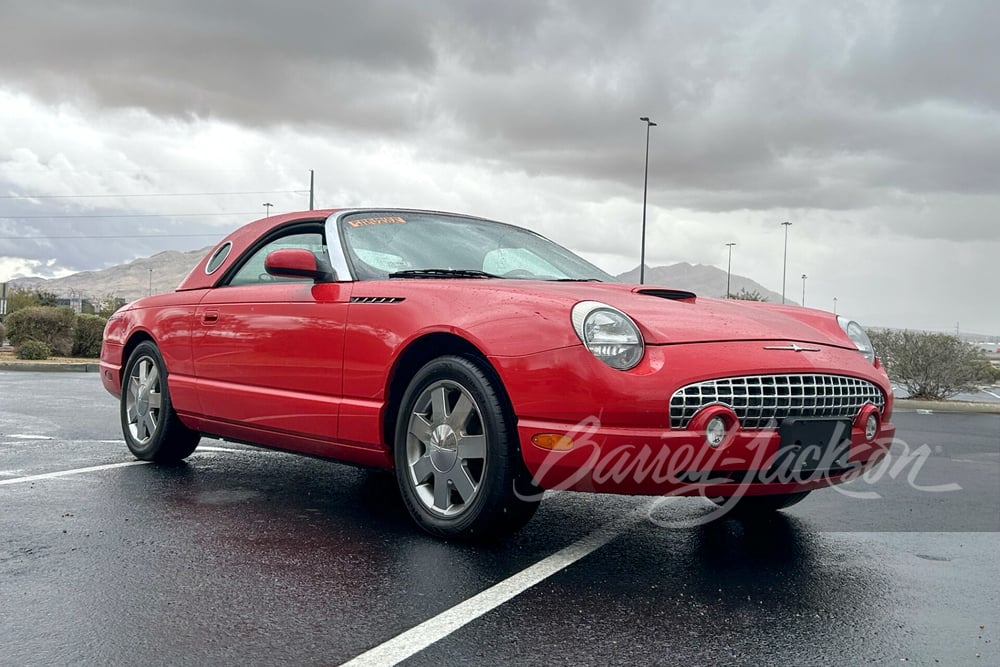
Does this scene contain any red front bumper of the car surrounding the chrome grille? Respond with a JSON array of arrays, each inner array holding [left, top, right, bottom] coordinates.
[[498, 341, 896, 497]]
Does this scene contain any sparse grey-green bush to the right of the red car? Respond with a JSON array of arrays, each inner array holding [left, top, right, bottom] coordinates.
[[869, 329, 989, 401]]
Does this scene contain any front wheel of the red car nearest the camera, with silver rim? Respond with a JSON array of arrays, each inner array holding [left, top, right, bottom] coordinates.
[[394, 356, 541, 541]]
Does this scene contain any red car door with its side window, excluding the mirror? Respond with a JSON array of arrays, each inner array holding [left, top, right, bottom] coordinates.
[[192, 224, 351, 446]]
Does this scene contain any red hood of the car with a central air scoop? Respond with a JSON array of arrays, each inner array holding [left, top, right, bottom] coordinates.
[[520, 283, 854, 349]]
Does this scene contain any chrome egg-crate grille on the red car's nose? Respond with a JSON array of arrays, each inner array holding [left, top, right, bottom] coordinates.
[[670, 374, 885, 429]]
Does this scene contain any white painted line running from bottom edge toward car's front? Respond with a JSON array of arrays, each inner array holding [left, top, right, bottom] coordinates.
[[342, 521, 634, 667]]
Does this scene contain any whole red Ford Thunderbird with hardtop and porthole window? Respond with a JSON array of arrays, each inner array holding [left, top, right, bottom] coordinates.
[[101, 209, 895, 538]]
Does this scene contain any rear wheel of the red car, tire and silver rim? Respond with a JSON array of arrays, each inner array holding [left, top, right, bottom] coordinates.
[[120, 341, 201, 463]]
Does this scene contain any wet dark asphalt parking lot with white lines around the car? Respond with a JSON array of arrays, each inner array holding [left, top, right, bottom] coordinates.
[[0, 372, 1000, 665]]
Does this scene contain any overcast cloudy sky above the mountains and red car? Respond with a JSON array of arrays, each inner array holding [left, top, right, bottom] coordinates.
[[0, 0, 1000, 335]]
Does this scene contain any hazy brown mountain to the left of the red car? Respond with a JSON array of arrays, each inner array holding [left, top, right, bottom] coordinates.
[[8, 248, 209, 301]]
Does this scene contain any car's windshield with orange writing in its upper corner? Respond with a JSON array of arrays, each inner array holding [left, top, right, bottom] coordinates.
[[340, 211, 615, 282]]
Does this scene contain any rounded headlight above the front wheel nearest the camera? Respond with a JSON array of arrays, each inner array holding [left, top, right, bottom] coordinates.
[[572, 301, 644, 371]]
